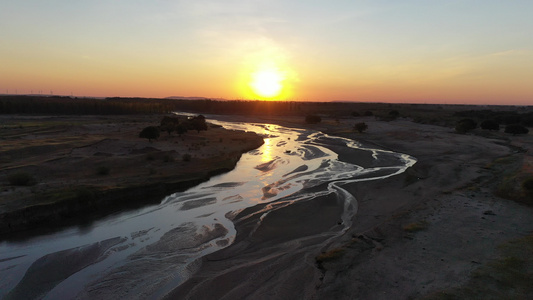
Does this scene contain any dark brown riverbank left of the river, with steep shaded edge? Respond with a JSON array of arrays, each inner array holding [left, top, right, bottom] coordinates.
[[0, 115, 263, 238]]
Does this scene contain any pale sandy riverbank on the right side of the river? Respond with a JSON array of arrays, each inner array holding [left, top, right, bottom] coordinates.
[[168, 117, 533, 299]]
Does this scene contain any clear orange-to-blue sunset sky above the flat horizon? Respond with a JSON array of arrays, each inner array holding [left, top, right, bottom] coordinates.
[[0, 0, 533, 105]]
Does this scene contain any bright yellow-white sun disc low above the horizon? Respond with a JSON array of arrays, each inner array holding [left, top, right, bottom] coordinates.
[[250, 69, 284, 98]]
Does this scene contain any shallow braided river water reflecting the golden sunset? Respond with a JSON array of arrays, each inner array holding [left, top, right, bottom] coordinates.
[[0, 121, 416, 299]]
